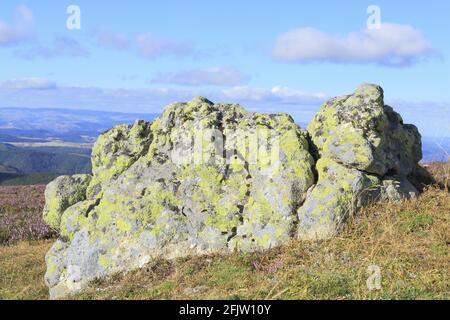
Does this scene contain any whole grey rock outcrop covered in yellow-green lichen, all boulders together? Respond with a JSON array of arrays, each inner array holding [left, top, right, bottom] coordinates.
[[44, 85, 422, 298]]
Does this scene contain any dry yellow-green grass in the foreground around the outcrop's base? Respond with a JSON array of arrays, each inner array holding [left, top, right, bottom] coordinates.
[[0, 165, 450, 299]]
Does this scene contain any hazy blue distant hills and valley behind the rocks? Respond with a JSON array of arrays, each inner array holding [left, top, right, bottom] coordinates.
[[0, 108, 450, 184]]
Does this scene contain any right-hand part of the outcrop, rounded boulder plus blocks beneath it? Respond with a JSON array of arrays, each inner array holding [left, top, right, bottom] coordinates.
[[298, 84, 422, 239]]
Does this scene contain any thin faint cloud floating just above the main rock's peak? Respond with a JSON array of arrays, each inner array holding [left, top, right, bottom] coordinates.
[[151, 67, 250, 86]]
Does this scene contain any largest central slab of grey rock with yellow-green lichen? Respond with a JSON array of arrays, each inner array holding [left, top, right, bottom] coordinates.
[[46, 98, 315, 297]]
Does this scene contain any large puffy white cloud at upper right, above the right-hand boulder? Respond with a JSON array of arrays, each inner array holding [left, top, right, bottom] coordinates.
[[272, 23, 432, 67]]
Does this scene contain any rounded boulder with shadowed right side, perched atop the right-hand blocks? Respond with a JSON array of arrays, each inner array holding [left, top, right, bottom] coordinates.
[[308, 84, 422, 176]]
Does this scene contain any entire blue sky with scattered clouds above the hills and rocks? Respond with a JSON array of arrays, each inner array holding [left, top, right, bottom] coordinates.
[[0, 0, 450, 136]]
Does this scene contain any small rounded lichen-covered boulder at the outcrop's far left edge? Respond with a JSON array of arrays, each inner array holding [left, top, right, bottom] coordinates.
[[44, 175, 92, 231]]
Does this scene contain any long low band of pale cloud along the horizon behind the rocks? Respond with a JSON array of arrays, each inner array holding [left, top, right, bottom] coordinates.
[[0, 78, 450, 137]]
